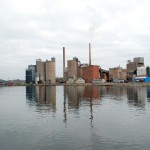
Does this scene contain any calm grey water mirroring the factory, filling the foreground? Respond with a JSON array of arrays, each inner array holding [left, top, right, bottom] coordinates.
[[0, 86, 150, 150]]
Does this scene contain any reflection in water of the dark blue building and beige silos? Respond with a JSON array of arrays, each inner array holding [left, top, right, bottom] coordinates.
[[26, 86, 56, 112]]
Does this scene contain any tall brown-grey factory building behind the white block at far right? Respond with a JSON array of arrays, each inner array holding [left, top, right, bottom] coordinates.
[[127, 57, 144, 80]]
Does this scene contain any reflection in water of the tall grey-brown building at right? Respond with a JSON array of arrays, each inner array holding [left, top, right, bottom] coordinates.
[[127, 87, 147, 108]]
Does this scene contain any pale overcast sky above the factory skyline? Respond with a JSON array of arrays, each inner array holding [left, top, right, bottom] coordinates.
[[0, 0, 150, 80]]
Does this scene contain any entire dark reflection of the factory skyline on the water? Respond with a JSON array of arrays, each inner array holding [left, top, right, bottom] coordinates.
[[26, 86, 150, 126]]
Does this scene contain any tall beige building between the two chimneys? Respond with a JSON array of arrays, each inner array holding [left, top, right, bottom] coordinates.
[[67, 57, 80, 79]]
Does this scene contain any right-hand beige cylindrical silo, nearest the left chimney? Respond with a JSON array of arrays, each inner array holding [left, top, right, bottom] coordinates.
[[45, 57, 56, 84]]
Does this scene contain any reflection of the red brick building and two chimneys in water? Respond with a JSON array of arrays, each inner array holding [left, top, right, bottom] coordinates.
[[64, 86, 100, 126]]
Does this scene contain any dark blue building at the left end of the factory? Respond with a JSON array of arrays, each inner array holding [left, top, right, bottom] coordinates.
[[26, 65, 36, 83]]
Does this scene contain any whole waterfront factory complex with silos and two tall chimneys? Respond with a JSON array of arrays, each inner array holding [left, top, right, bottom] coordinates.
[[26, 43, 150, 85]]
